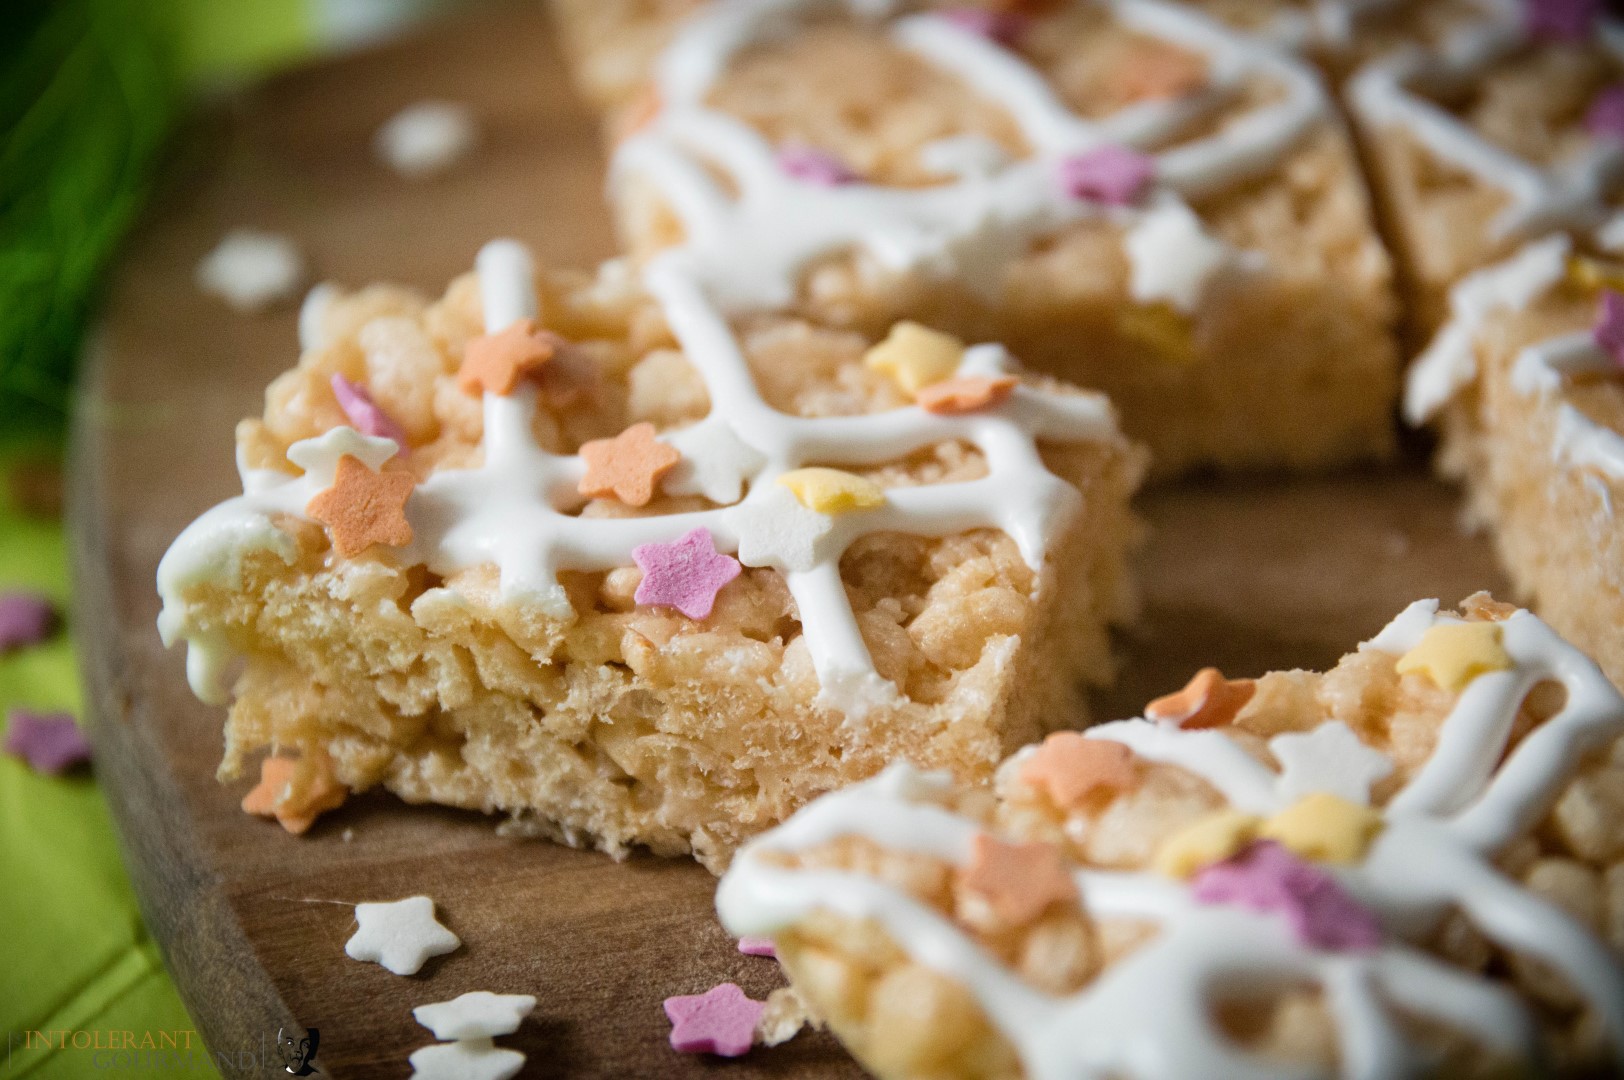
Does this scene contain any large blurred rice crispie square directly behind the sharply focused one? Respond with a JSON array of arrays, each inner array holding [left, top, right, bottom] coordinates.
[[562, 0, 1398, 474]]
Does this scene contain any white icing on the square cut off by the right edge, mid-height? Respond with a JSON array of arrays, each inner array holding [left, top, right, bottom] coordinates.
[[1405, 234, 1624, 483]]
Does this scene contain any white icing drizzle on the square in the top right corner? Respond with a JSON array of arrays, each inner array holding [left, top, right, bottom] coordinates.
[[1348, 5, 1624, 242]]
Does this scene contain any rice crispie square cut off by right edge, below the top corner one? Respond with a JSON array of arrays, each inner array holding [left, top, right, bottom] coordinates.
[[1405, 235, 1624, 685]]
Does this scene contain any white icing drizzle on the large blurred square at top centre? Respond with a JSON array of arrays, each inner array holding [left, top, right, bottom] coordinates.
[[611, 0, 1328, 310]]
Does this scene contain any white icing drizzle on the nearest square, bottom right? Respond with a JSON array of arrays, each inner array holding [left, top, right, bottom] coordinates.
[[716, 601, 1624, 1080]]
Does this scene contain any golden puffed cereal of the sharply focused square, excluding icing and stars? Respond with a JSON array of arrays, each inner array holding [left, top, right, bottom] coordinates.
[[171, 268, 1142, 869]]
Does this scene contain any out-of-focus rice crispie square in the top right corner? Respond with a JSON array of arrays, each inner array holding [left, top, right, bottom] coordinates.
[[1346, 3, 1624, 337]]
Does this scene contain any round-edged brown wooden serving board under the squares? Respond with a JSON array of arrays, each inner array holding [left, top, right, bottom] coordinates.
[[71, 0, 1501, 1078]]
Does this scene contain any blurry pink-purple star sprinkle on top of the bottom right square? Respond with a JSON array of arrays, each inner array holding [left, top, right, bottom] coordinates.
[[1192, 840, 1382, 952]]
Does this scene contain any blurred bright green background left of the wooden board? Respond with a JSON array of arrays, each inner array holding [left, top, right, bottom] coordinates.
[[0, 0, 467, 1080]]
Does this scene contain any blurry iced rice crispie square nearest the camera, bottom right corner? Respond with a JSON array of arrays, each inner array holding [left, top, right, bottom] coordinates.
[[718, 594, 1624, 1080]]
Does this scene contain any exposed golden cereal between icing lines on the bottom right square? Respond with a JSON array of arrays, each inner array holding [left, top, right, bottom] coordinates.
[[770, 596, 1624, 1080]]
